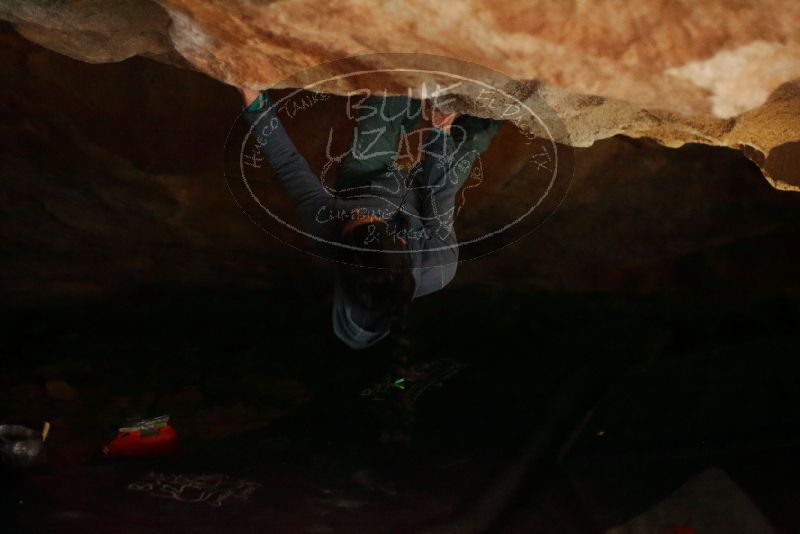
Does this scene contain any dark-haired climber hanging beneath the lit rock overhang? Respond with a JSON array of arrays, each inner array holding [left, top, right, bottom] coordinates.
[[240, 89, 500, 349]]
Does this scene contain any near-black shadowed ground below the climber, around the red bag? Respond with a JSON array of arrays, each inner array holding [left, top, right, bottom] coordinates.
[[0, 288, 800, 532]]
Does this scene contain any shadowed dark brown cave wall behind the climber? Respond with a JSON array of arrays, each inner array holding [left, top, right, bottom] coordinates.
[[0, 27, 800, 304]]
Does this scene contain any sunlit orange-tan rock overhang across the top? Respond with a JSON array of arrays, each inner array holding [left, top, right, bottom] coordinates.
[[0, 0, 800, 190]]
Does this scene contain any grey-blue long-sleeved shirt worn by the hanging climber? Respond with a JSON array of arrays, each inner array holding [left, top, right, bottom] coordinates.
[[244, 93, 497, 346]]
